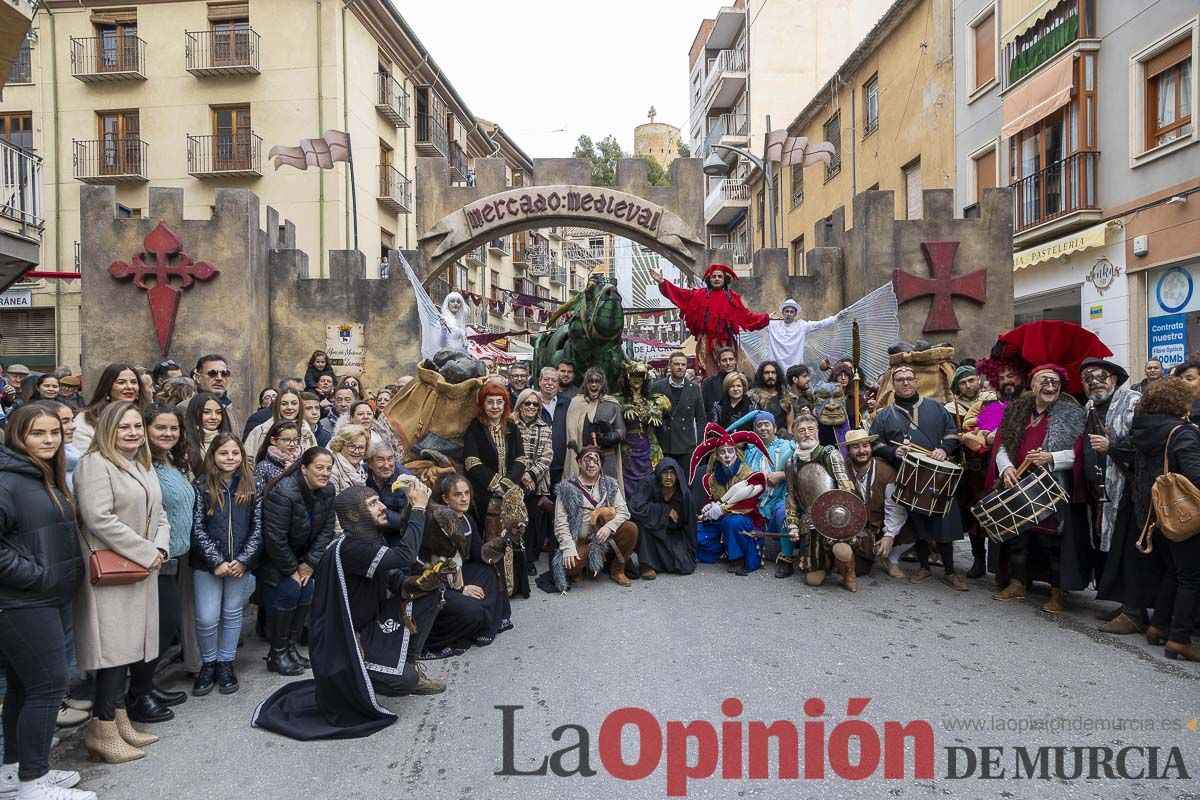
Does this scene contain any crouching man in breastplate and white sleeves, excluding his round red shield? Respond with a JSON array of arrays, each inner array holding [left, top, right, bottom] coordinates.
[[776, 415, 874, 591]]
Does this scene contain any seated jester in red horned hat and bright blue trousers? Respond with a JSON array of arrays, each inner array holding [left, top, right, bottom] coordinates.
[[689, 422, 770, 576]]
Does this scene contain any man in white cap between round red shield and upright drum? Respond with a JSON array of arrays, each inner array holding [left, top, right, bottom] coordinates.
[[840, 428, 916, 578]]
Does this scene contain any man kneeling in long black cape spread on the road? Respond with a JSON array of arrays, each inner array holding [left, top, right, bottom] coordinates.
[[252, 483, 450, 740]]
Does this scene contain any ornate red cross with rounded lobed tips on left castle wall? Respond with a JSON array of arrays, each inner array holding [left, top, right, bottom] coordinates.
[[108, 222, 221, 356]]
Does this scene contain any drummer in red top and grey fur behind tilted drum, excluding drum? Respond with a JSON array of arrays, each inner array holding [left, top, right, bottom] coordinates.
[[989, 363, 1091, 614]]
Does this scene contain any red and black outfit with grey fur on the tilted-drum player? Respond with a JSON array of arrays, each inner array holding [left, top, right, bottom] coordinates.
[[994, 395, 1092, 591]]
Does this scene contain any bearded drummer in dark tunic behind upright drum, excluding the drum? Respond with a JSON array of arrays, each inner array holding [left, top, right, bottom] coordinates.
[[871, 363, 967, 591]]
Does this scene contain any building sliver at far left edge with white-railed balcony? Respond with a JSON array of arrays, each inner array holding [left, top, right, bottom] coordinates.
[[0, 0, 44, 352]]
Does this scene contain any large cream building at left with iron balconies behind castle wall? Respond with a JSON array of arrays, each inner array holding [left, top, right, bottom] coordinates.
[[0, 0, 583, 366]]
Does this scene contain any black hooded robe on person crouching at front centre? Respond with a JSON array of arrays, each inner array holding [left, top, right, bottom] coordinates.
[[629, 458, 696, 575]]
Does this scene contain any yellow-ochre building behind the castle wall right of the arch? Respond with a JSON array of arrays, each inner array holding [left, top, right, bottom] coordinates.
[[745, 0, 955, 275]]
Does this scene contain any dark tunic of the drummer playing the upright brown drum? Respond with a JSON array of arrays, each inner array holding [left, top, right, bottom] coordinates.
[[871, 396, 962, 542]]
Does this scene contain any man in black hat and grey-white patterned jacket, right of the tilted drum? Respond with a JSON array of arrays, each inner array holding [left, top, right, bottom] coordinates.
[[1079, 356, 1158, 634]]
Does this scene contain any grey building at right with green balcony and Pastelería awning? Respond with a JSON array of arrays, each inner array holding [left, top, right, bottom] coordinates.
[[954, 0, 1200, 372]]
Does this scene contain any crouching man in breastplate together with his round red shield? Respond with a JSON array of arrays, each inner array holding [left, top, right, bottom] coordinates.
[[775, 414, 872, 591]]
